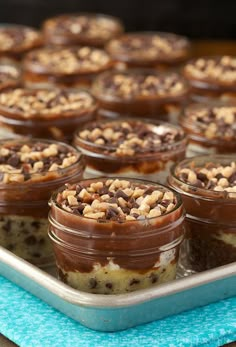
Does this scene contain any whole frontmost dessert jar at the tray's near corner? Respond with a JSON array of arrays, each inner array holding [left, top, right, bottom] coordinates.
[[49, 178, 184, 294]]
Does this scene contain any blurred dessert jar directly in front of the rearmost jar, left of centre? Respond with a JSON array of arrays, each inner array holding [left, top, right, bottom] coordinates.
[[23, 46, 113, 88]]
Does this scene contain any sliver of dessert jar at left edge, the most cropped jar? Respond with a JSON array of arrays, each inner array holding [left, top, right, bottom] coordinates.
[[0, 60, 21, 92]]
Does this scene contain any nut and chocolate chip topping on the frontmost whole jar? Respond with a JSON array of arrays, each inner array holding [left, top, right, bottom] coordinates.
[[56, 179, 177, 222]]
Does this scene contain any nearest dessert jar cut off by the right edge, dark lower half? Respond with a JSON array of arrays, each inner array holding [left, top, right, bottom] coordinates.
[[168, 155, 236, 273]]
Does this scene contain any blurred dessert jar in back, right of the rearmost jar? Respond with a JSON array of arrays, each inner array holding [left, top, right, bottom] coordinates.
[[106, 32, 190, 69]]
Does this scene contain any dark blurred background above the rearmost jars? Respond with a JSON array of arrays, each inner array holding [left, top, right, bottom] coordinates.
[[0, 0, 236, 38]]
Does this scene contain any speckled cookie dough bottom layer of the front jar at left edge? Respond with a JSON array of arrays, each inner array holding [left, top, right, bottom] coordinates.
[[0, 215, 54, 266]]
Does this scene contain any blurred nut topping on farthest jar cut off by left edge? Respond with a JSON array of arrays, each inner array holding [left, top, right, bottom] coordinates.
[[0, 25, 41, 53]]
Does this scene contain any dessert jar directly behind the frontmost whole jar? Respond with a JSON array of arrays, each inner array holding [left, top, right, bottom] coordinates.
[[74, 118, 187, 183]]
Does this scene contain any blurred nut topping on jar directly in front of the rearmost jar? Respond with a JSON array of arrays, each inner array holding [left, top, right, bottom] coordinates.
[[24, 47, 111, 75]]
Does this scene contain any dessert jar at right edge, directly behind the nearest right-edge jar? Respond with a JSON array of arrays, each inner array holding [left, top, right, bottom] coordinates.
[[180, 102, 236, 156]]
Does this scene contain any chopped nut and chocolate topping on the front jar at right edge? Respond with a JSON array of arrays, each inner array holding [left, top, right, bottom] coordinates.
[[177, 160, 236, 198]]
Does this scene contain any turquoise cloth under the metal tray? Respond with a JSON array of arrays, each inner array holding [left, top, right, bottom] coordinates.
[[0, 277, 236, 347]]
